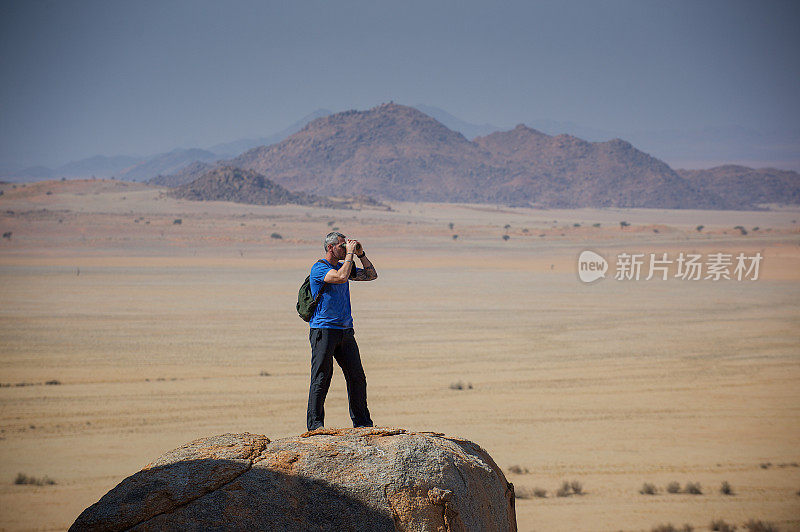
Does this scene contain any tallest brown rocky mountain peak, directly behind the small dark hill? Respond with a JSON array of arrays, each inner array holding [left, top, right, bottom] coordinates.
[[232, 104, 502, 201]]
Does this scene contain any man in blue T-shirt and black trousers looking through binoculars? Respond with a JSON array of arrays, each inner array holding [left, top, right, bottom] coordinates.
[[306, 231, 378, 430]]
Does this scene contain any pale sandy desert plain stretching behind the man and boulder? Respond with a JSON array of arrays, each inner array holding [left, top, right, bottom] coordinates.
[[0, 181, 800, 531]]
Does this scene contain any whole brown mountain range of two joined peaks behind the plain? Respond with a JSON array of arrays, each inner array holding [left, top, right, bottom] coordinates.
[[156, 103, 788, 209]]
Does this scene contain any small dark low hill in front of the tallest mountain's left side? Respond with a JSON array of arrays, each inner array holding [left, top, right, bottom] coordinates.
[[169, 165, 388, 209]]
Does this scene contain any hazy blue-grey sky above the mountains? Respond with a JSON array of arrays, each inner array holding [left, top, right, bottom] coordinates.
[[0, 0, 800, 167]]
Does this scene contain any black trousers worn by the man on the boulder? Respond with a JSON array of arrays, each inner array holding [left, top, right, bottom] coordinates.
[[306, 329, 372, 430]]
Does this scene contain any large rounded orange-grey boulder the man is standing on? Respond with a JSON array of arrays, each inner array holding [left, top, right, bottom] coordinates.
[[70, 428, 516, 531]]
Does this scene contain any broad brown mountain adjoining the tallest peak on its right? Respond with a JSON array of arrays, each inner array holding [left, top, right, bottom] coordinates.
[[475, 124, 732, 209]]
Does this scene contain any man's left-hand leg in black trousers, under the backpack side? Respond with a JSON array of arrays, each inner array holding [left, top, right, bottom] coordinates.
[[306, 329, 342, 430]]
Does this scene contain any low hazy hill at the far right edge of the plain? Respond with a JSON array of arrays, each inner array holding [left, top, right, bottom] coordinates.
[[677, 164, 800, 205]]
